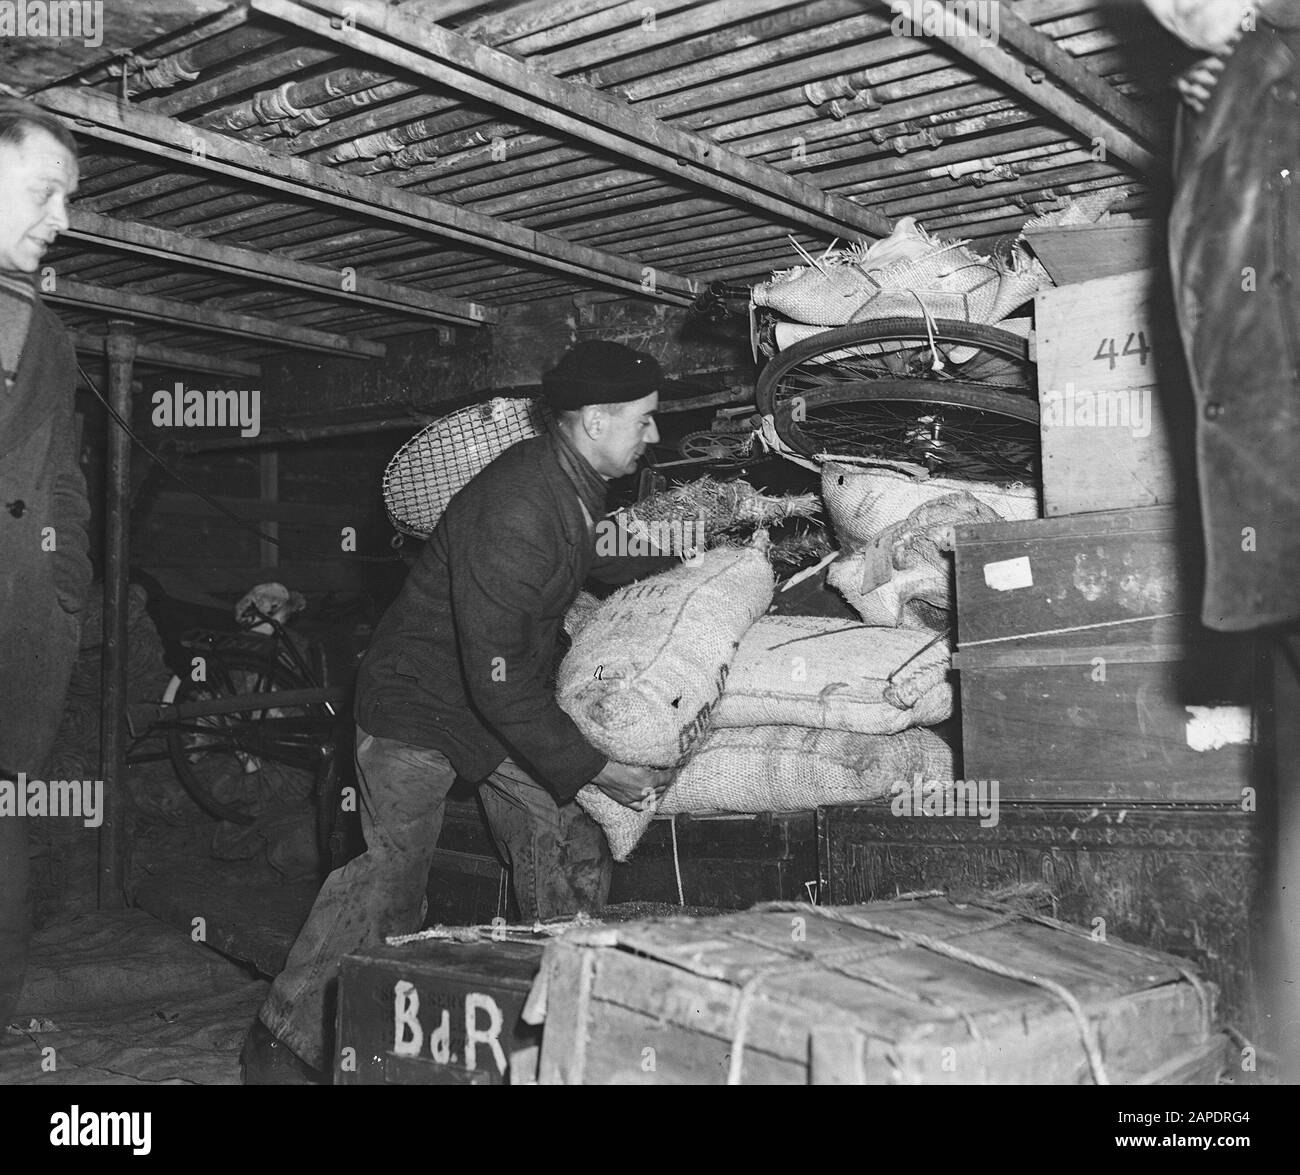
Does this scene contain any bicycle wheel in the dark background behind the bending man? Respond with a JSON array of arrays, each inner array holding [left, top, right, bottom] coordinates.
[[164, 652, 333, 824]]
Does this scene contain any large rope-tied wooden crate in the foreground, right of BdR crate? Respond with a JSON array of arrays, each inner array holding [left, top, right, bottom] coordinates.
[[525, 899, 1225, 1085]]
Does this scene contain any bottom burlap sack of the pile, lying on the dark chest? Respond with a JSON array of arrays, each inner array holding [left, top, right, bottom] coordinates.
[[660, 727, 953, 815]]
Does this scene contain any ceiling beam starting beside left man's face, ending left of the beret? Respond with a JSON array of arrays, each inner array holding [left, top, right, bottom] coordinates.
[[64, 207, 501, 326]]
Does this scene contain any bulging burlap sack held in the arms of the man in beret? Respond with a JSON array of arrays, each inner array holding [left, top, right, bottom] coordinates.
[[555, 547, 775, 767]]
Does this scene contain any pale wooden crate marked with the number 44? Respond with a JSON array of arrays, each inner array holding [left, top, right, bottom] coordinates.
[[1035, 269, 1195, 517]]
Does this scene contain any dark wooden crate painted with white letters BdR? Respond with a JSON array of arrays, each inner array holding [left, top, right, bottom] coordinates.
[[334, 941, 542, 1085]]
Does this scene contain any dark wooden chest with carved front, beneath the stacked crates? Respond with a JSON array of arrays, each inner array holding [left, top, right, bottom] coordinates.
[[818, 803, 1268, 1036]]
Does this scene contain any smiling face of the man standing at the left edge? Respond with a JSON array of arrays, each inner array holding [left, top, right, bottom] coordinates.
[[0, 127, 77, 273]]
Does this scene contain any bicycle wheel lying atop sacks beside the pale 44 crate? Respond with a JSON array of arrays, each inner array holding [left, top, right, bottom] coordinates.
[[757, 318, 1039, 482]]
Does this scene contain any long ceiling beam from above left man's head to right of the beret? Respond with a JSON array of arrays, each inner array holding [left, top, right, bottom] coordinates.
[[39, 87, 696, 305]]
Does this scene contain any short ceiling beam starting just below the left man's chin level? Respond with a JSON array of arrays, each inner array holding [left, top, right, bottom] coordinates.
[[42, 278, 385, 359]]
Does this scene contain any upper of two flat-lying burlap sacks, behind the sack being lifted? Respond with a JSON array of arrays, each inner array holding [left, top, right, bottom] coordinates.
[[712, 616, 953, 734]]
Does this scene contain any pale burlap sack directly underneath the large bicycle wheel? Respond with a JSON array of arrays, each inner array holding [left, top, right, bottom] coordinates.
[[822, 461, 1039, 547]]
